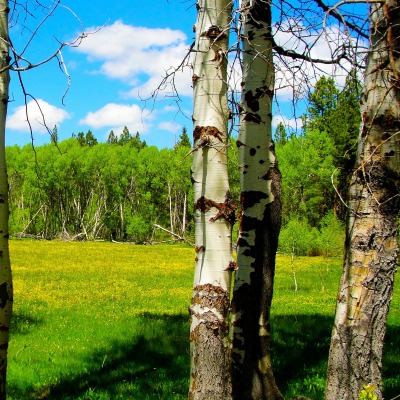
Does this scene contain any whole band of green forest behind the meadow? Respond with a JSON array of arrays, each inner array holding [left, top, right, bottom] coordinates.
[[6, 74, 360, 255]]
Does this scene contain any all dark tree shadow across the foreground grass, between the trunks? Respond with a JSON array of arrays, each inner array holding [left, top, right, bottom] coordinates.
[[9, 314, 400, 400]]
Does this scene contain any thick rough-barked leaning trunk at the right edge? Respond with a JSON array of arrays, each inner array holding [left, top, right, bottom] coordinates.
[[325, 0, 400, 400]]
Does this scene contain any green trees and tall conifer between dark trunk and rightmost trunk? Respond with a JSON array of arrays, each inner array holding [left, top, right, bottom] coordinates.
[[275, 72, 360, 244]]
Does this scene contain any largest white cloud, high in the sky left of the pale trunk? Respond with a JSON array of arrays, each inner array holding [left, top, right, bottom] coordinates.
[[77, 21, 192, 98]]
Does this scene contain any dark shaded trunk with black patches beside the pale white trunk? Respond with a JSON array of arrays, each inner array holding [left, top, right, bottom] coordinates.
[[232, 0, 283, 400]]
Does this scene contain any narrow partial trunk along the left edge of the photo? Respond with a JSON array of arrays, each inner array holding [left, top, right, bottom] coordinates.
[[0, 1, 13, 400]]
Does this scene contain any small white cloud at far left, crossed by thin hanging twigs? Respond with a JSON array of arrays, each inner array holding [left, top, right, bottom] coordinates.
[[7, 99, 70, 134]]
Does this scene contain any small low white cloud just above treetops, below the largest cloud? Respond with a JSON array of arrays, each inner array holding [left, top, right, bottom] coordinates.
[[79, 103, 153, 133]]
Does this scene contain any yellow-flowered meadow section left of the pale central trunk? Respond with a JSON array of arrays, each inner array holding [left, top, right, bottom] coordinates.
[[8, 241, 193, 400]]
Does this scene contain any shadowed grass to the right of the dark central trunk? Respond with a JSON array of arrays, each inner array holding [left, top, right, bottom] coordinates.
[[271, 315, 400, 400]]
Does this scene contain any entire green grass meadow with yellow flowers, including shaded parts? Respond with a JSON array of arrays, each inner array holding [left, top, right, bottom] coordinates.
[[8, 240, 400, 400]]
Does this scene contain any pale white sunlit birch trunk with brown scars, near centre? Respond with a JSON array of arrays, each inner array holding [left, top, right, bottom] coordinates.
[[189, 0, 235, 400]]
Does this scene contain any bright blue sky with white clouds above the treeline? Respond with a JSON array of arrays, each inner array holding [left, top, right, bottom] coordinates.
[[6, 0, 368, 148]]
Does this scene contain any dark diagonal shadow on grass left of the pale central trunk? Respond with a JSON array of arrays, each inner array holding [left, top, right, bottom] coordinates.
[[9, 314, 190, 400]]
